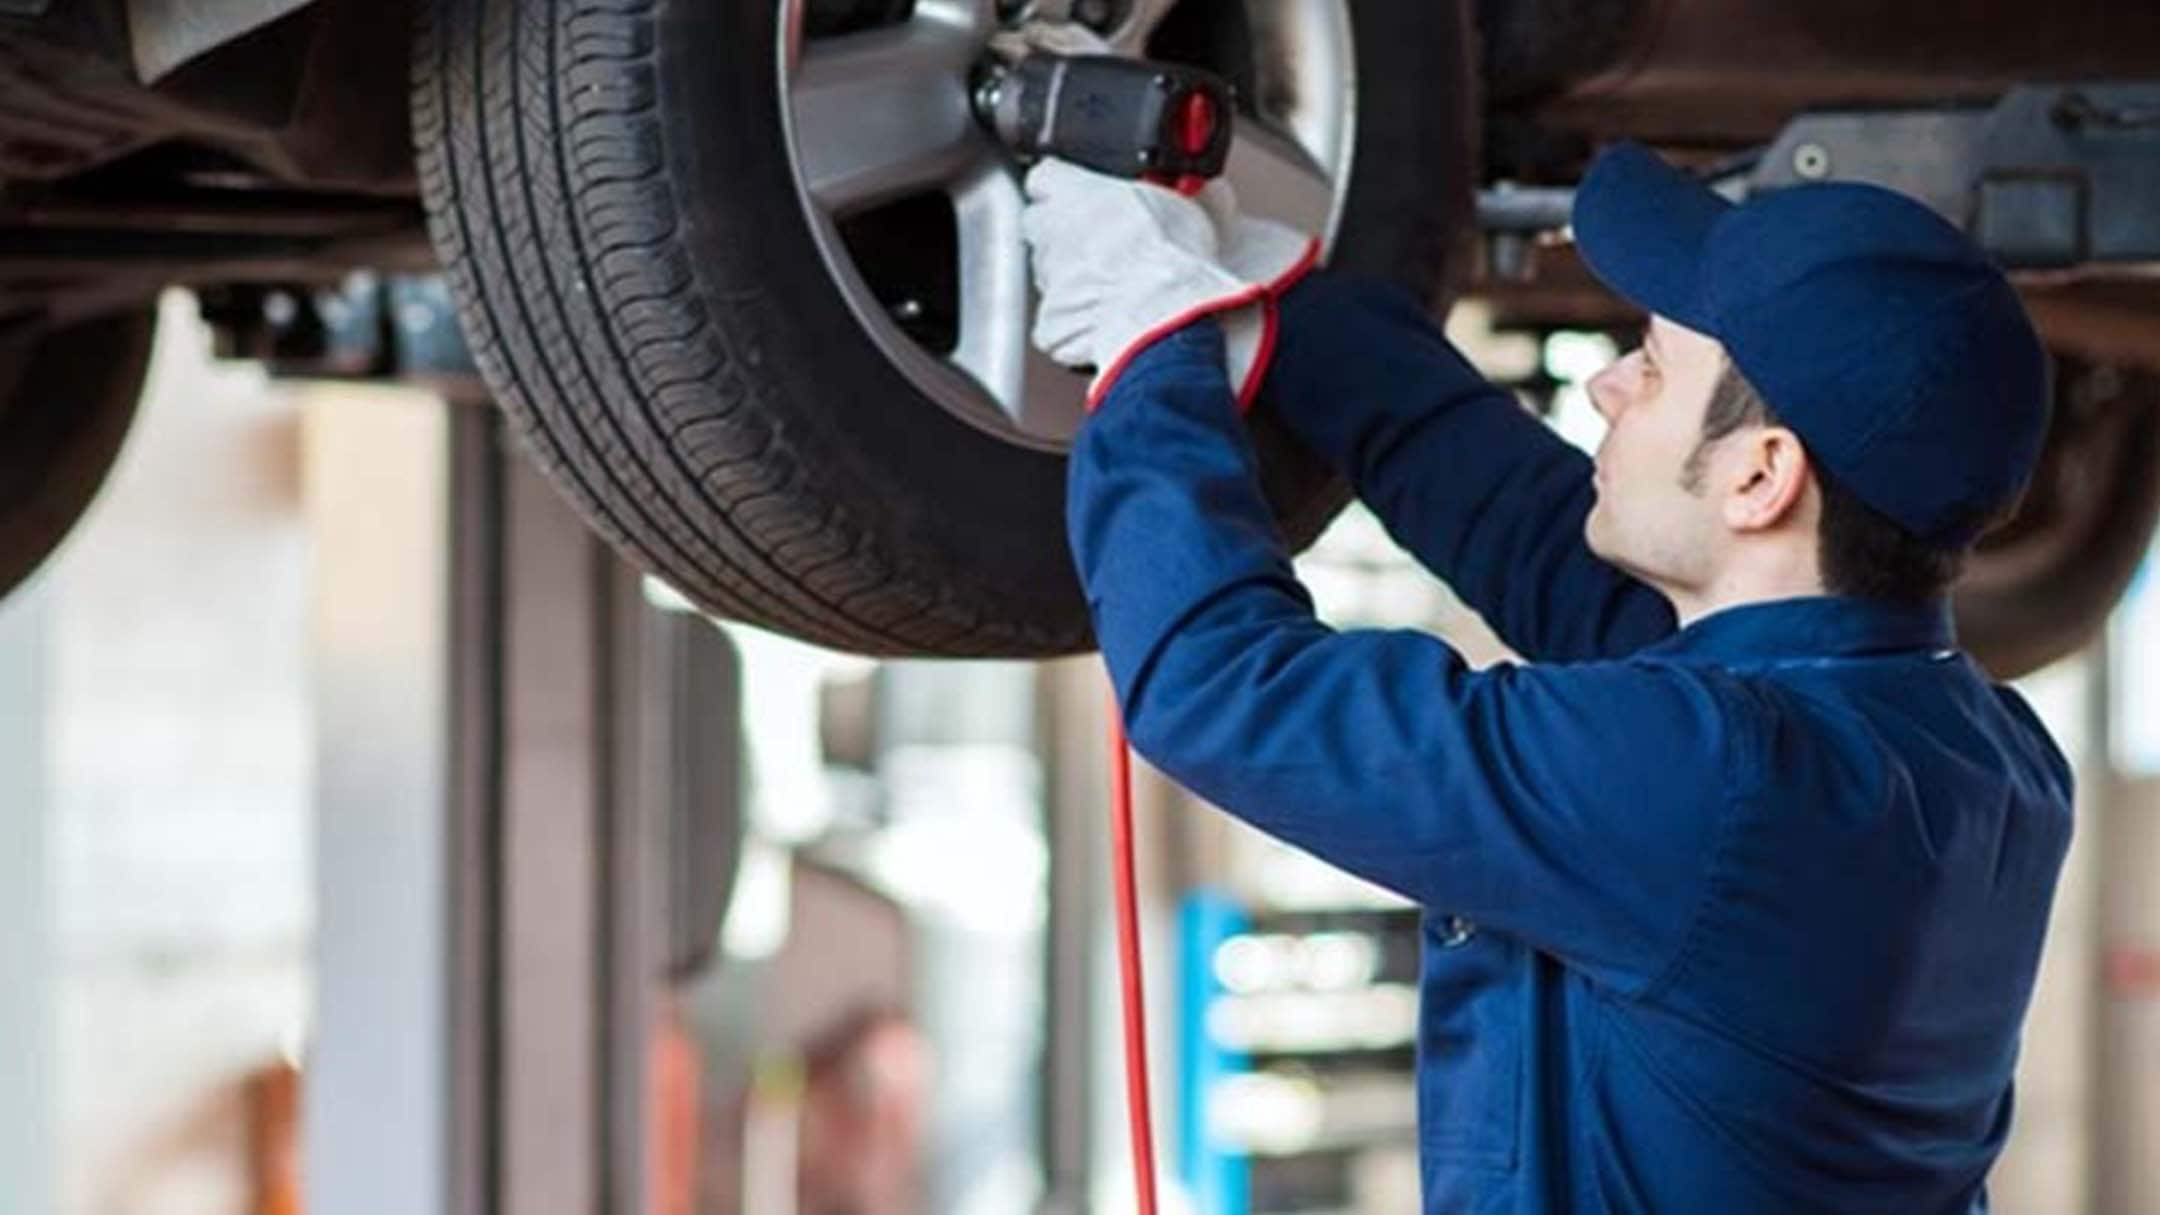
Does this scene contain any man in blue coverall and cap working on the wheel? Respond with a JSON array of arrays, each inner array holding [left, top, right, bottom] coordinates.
[[1026, 145, 2071, 1215]]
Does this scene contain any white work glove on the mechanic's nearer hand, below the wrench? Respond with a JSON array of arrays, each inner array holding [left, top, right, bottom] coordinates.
[[1020, 160, 1261, 409]]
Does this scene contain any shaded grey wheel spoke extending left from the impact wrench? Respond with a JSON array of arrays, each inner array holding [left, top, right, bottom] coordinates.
[[788, 9, 987, 216]]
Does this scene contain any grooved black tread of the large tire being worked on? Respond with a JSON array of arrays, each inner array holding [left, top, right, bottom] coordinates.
[[413, 0, 1002, 655]]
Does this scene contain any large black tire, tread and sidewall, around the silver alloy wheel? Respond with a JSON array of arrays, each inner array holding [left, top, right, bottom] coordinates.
[[413, 0, 1475, 657]]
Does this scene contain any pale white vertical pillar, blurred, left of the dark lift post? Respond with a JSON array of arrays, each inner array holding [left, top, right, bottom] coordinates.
[[302, 389, 451, 1215]]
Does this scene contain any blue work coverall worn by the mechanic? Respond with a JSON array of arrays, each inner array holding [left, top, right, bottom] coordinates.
[[1069, 275, 2071, 1215]]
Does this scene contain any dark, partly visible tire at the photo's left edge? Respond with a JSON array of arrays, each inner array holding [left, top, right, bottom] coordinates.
[[0, 307, 158, 595]]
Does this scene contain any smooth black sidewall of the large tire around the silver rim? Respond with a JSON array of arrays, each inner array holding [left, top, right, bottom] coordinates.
[[557, 0, 1475, 655]]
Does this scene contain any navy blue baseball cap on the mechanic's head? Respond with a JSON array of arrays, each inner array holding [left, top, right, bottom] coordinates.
[[1575, 143, 2050, 547]]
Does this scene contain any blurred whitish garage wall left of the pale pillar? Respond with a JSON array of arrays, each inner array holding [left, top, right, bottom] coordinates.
[[41, 294, 311, 1215]]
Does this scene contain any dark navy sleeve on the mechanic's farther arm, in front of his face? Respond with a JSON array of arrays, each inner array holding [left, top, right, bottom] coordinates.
[[1261, 272, 1674, 662]]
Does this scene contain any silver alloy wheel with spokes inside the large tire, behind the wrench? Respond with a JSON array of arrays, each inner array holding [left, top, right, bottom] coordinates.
[[778, 0, 1354, 450]]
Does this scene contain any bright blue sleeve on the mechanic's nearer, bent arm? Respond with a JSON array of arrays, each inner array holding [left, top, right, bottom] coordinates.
[[1067, 322, 1734, 988]]
